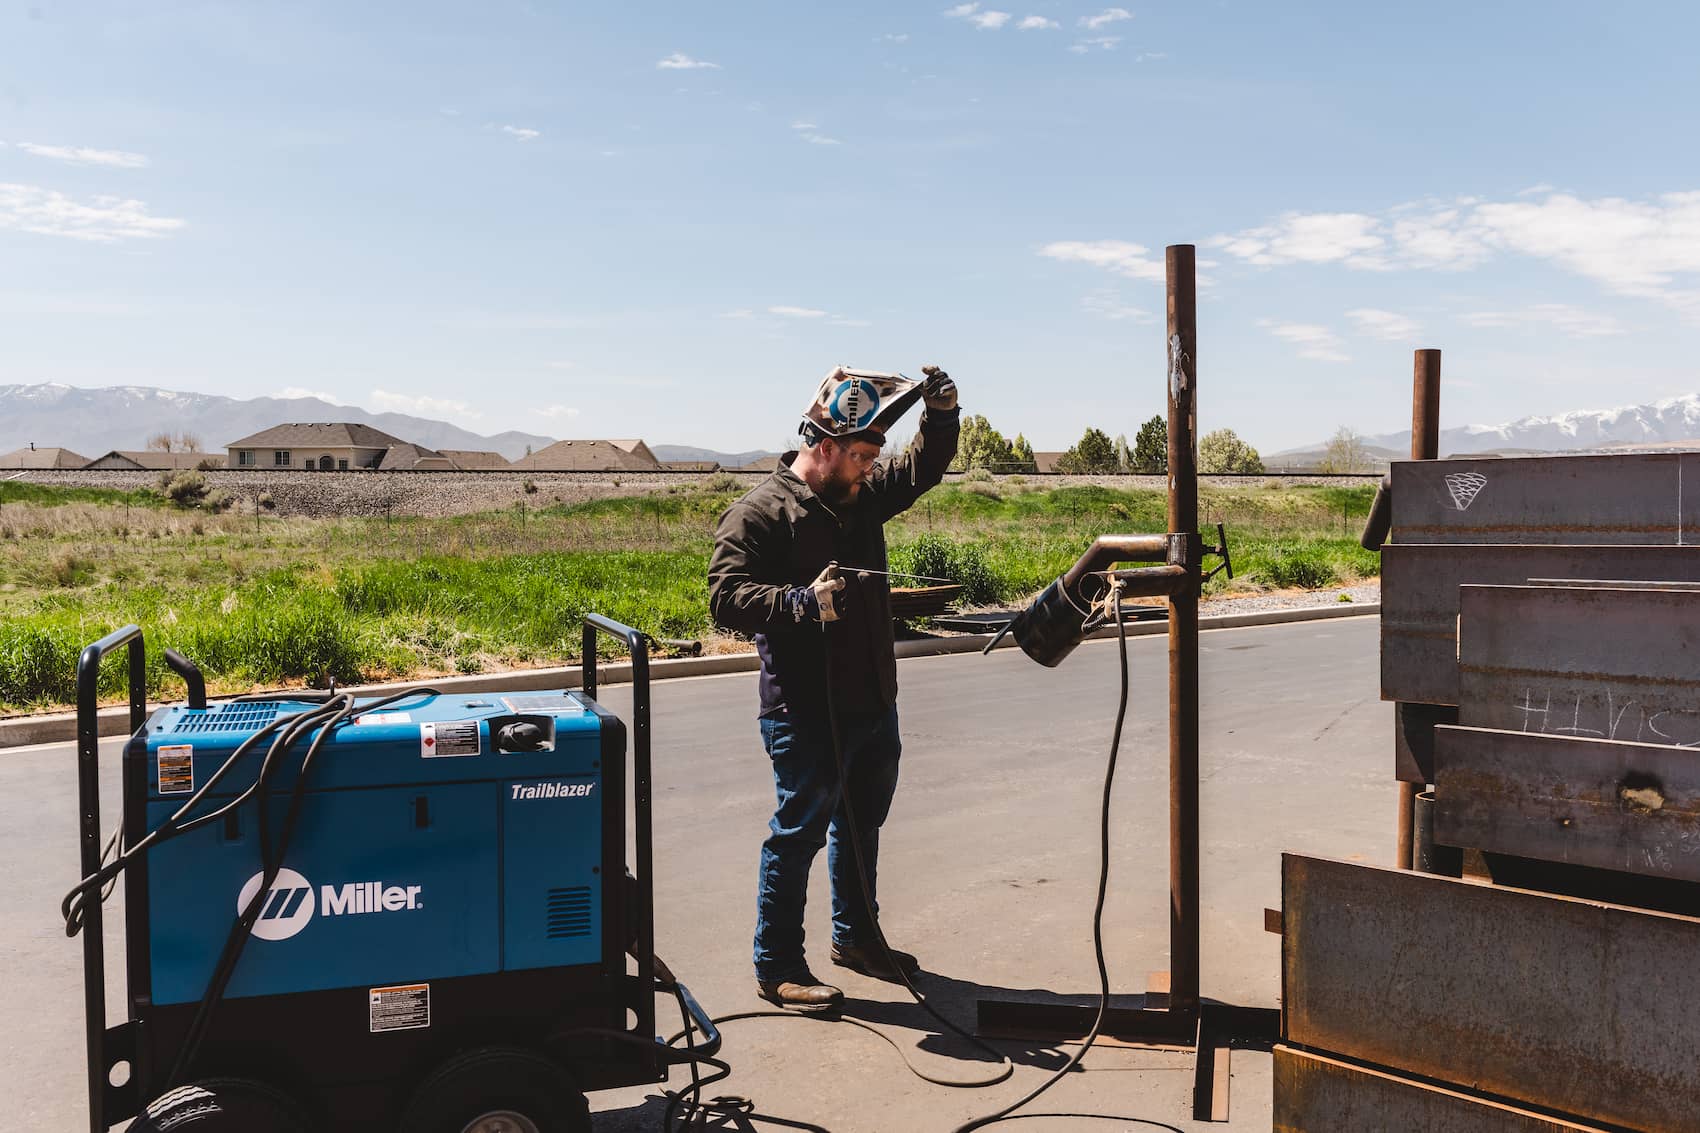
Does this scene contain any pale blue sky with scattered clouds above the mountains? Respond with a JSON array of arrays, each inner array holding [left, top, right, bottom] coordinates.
[[0, 0, 1700, 453]]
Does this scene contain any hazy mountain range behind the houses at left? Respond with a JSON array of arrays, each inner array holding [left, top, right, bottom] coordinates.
[[0, 383, 554, 459]]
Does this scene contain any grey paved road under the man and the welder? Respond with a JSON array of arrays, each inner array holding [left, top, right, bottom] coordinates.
[[0, 618, 1394, 1133]]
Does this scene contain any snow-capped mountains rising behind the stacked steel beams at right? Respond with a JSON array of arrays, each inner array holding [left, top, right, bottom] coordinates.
[[1365, 393, 1700, 456]]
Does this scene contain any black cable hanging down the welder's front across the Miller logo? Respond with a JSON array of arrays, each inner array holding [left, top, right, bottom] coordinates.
[[165, 687, 437, 1089]]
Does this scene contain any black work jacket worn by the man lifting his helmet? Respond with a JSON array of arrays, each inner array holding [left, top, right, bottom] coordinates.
[[709, 410, 959, 716]]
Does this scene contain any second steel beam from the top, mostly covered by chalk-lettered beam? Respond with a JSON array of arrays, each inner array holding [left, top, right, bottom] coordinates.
[[1380, 540, 1700, 704]]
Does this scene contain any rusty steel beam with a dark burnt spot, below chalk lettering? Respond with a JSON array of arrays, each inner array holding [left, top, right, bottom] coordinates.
[[1435, 728, 1700, 881]]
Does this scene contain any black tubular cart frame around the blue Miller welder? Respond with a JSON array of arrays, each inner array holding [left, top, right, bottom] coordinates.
[[77, 614, 721, 1133]]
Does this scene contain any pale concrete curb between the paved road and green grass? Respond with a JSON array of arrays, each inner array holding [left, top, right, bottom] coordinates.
[[0, 602, 1380, 749]]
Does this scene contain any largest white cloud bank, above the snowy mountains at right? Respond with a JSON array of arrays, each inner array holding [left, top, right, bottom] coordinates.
[[1209, 187, 1700, 320]]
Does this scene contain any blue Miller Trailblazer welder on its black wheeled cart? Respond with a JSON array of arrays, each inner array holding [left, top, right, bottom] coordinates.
[[63, 614, 719, 1133]]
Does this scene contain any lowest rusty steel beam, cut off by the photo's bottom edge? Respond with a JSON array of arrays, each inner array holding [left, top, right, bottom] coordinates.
[[1273, 1046, 1605, 1133]]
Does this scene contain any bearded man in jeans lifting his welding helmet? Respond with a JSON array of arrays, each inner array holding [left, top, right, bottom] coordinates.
[[709, 358, 959, 1014]]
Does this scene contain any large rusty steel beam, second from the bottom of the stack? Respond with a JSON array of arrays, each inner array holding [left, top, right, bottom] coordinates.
[[1282, 854, 1700, 1133]]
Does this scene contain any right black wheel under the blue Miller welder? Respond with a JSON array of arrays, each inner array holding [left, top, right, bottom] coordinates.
[[401, 1046, 590, 1133]]
